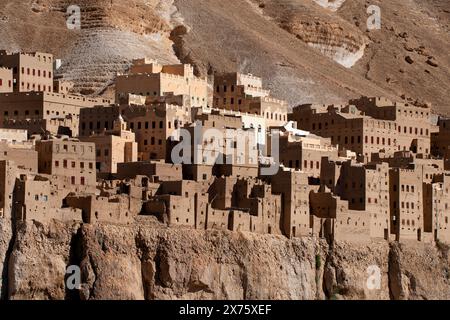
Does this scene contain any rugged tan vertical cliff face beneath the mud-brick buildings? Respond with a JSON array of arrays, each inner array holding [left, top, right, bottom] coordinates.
[[0, 220, 450, 299]]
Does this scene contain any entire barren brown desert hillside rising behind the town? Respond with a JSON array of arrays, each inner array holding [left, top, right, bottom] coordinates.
[[0, 0, 450, 113]]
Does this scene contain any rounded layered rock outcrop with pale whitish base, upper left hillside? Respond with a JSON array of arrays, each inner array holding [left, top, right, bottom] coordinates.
[[50, 0, 181, 94]]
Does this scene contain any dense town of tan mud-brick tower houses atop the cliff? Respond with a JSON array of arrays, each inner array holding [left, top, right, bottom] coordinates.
[[0, 50, 450, 244]]
